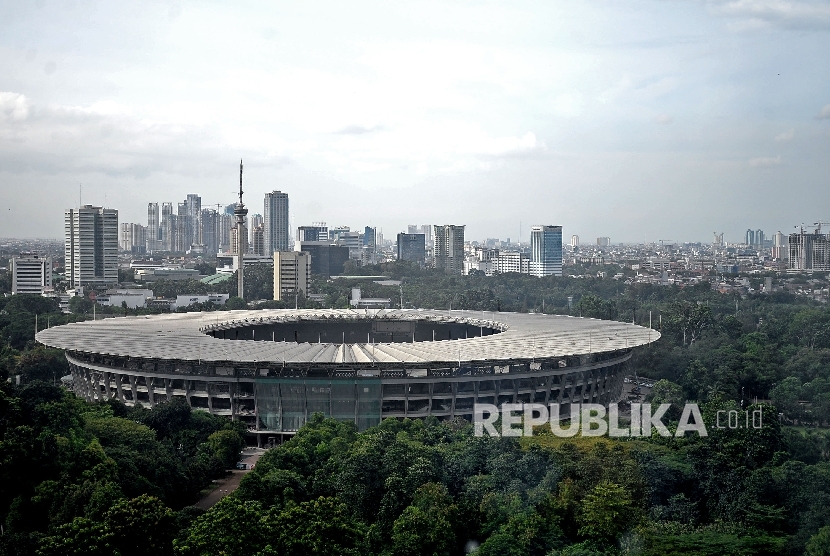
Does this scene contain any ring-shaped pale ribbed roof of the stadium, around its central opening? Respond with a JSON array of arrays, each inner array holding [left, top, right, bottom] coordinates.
[[36, 309, 660, 366]]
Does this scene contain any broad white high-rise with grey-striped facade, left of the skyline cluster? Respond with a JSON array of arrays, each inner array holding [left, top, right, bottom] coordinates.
[[64, 205, 118, 288]]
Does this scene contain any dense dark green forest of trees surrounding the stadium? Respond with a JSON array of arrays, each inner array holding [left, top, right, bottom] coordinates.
[[0, 264, 830, 556]]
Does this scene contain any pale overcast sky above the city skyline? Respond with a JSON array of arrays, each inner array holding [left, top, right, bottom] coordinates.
[[0, 0, 830, 243]]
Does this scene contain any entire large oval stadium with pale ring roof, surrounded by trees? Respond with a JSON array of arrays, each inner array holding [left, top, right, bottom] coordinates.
[[37, 309, 660, 445]]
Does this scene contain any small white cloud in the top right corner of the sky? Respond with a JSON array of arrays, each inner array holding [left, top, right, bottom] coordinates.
[[706, 0, 830, 31]]
